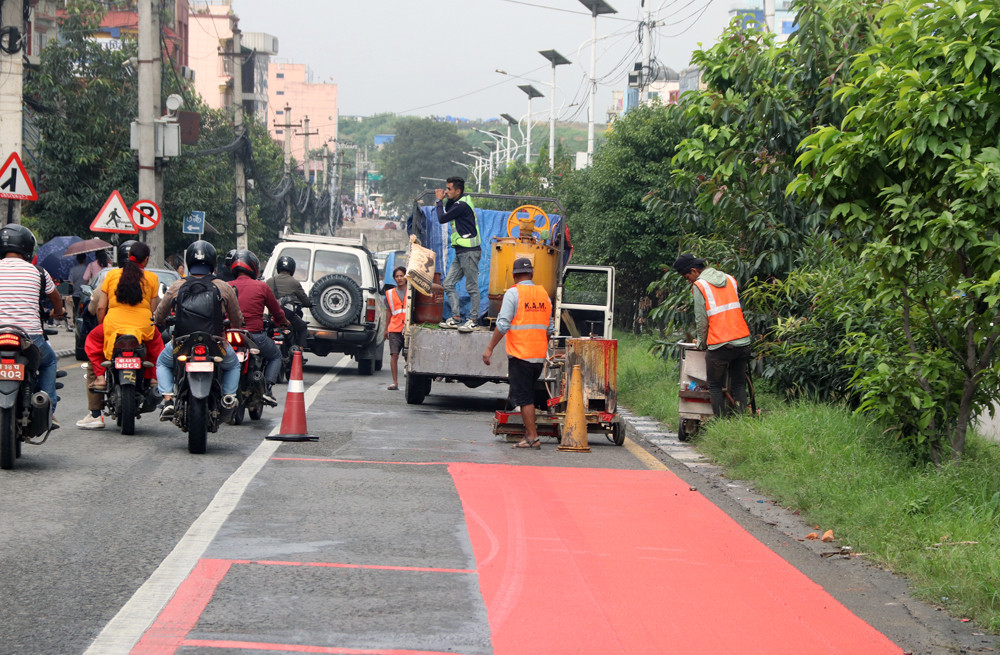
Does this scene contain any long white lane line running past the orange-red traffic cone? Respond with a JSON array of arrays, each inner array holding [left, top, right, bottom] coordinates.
[[84, 355, 350, 655]]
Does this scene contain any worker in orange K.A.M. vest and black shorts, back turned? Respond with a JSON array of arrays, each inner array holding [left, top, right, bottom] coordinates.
[[483, 257, 555, 450]]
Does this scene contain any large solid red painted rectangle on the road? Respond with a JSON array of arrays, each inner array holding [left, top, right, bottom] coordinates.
[[449, 464, 902, 655]]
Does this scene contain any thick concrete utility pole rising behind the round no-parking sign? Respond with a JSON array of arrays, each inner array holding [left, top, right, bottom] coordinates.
[[138, 0, 166, 263]]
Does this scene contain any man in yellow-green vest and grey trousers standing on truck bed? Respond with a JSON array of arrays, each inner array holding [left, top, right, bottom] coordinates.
[[434, 177, 483, 332]]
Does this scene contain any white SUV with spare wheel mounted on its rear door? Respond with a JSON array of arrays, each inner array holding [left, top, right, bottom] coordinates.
[[263, 233, 386, 375]]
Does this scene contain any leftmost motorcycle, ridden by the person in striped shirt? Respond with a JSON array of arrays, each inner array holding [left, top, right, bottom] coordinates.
[[0, 325, 66, 470]]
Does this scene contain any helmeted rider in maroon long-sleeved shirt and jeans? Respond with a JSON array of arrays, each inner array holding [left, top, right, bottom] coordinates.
[[229, 250, 288, 407]]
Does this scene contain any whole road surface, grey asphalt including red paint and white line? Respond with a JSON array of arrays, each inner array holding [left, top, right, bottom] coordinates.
[[0, 344, 994, 655]]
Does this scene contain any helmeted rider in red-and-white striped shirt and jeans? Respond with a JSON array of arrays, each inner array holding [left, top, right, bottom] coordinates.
[[0, 223, 66, 427]]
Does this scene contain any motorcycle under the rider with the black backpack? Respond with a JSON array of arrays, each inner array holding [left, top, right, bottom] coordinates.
[[173, 332, 237, 455]]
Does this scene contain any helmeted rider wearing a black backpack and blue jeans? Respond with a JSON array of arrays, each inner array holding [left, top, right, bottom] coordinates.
[[153, 241, 243, 421]]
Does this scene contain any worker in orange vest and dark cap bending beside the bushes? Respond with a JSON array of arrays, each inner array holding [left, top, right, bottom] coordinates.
[[674, 252, 750, 417]]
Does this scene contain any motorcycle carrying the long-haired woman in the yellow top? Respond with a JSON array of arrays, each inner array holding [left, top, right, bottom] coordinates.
[[102, 334, 160, 434]]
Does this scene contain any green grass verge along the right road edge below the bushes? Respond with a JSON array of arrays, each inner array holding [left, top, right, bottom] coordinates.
[[618, 337, 1000, 632]]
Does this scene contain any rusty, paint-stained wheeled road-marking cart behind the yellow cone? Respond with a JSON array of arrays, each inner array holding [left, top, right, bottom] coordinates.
[[493, 337, 625, 446]]
